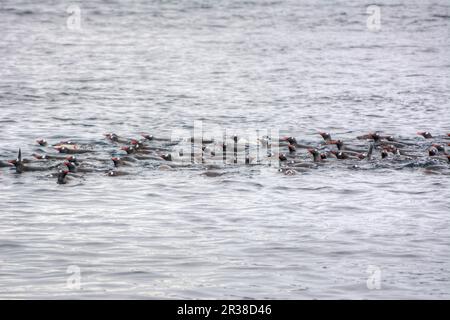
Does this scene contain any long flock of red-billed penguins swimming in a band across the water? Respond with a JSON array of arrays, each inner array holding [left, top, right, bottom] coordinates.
[[0, 132, 450, 184]]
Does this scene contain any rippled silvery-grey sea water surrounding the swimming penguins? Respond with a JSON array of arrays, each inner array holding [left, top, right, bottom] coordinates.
[[0, 0, 450, 299]]
